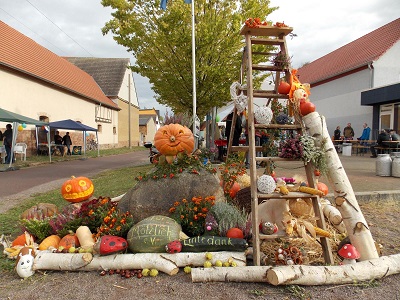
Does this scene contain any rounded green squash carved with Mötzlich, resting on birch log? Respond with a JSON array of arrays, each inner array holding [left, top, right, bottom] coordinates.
[[127, 215, 182, 253]]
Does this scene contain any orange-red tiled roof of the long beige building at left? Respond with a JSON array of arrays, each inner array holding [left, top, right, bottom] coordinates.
[[0, 21, 118, 109]]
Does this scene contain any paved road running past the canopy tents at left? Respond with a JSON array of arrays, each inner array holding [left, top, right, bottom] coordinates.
[[0, 150, 149, 203]]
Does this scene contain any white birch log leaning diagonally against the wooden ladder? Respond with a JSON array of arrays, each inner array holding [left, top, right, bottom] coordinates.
[[303, 112, 379, 261]]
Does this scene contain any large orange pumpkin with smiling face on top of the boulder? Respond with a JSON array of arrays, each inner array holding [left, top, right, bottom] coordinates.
[[154, 124, 194, 156]]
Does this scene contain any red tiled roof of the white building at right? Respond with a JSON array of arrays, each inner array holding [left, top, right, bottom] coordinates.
[[298, 18, 400, 85]]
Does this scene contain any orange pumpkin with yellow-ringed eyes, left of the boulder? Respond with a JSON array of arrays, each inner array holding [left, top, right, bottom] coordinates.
[[61, 176, 94, 203]]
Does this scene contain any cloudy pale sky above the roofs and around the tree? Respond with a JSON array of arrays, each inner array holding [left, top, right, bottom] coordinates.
[[0, 0, 400, 116]]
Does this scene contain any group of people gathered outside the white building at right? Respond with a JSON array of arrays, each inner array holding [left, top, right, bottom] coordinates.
[[333, 123, 400, 157]]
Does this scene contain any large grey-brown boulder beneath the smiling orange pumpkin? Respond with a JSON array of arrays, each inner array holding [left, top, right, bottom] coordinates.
[[118, 170, 223, 222]]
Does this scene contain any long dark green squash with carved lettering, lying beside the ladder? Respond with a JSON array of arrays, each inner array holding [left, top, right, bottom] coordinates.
[[181, 236, 249, 252]]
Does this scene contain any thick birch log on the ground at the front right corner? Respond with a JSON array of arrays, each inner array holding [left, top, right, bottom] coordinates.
[[267, 254, 400, 285]]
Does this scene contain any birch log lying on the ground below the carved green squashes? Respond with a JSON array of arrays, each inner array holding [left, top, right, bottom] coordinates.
[[33, 251, 246, 275]]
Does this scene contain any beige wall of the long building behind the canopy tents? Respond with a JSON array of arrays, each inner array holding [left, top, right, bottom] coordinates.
[[0, 69, 118, 152]]
